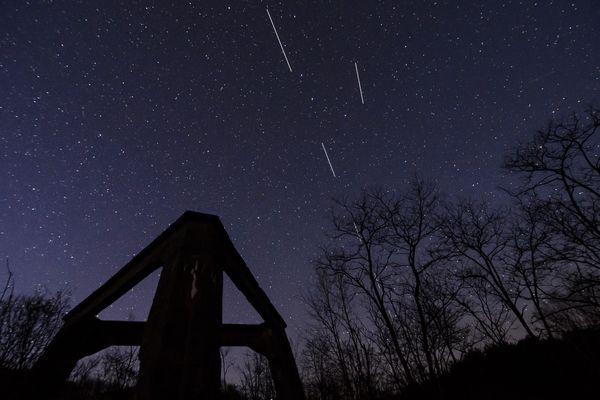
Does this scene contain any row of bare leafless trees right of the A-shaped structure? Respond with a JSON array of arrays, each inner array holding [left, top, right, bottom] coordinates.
[[301, 109, 600, 399]]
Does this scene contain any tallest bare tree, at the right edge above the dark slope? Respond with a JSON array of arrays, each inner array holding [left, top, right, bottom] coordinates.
[[505, 107, 600, 323]]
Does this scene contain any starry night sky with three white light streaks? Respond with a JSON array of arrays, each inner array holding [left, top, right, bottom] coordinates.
[[0, 0, 600, 337]]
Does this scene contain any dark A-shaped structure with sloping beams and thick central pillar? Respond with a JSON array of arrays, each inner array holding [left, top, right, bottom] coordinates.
[[30, 211, 304, 400]]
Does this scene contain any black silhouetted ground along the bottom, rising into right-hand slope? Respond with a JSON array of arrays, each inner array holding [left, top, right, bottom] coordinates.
[[0, 328, 600, 400]]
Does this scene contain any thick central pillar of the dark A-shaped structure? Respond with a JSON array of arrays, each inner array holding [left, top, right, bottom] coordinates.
[[136, 225, 223, 400]]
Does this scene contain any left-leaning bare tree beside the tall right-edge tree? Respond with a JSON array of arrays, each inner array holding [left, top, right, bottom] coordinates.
[[443, 201, 535, 341]]
